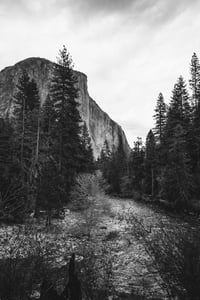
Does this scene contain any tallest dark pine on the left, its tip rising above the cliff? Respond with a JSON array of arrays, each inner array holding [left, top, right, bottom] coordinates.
[[50, 46, 81, 198]]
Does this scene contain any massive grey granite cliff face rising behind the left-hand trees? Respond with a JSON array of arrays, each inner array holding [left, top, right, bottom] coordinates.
[[0, 58, 130, 158]]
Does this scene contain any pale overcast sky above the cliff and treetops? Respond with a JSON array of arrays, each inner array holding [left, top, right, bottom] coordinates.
[[0, 0, 200, 146]]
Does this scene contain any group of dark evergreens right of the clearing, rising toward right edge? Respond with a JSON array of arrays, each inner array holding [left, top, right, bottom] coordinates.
[[100, 53, 200, 211]]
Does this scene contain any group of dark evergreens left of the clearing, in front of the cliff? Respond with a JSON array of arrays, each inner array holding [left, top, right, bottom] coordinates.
[[0, 46, 94, 220]]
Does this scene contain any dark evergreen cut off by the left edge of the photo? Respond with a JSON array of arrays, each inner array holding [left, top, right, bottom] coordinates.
[[0, 119, 25, 221]]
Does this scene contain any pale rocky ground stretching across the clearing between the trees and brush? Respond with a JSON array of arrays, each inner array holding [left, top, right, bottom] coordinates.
[[0, 196, 195, 299]]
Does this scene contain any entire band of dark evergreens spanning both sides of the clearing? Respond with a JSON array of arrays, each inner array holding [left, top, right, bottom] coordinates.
[[0, 47, 200, 219]]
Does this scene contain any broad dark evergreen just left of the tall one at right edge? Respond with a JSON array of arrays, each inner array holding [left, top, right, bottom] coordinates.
[[161, 77, 192, 205]]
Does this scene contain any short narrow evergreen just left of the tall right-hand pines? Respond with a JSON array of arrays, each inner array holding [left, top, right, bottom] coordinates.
[[144, 130, 157, 196]]
